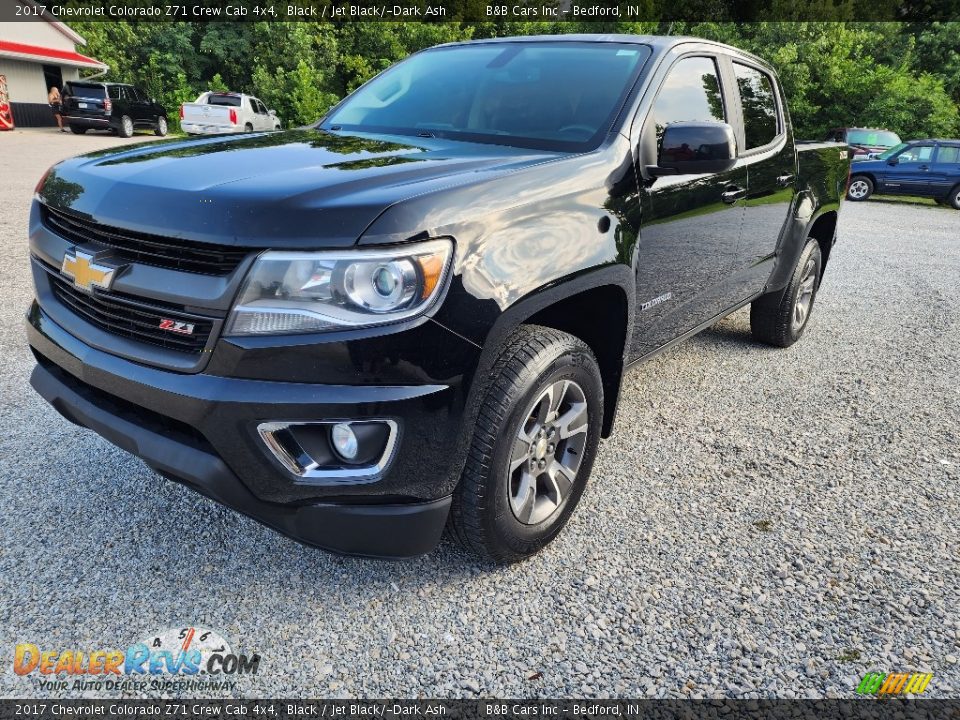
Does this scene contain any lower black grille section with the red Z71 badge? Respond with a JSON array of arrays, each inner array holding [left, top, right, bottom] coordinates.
[[49, 273, 213, 354]]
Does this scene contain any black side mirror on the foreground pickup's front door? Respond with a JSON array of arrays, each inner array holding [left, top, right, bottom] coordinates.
[[647, 122, 737, 177]]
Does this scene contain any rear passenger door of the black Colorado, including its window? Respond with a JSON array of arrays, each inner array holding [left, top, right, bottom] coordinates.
[[728, 57, 797, 298]]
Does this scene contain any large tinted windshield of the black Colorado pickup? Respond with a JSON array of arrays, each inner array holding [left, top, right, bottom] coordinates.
[[321, 42, 650, 150]]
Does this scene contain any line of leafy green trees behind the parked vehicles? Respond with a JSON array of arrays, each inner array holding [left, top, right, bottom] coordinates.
[[72, 21, 960, 138]]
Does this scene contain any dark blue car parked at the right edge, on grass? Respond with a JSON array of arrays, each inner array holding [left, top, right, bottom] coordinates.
[[847, 140, 960, 210]]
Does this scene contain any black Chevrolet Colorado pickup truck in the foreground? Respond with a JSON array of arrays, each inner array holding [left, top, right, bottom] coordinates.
[[27, 35, 849, 562]]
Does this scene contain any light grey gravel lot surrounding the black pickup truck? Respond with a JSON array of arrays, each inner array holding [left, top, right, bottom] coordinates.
[[0, 131, 960, 697]]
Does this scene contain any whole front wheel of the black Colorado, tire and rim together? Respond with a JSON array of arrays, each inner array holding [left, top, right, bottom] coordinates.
[[450, 325, 603, 563]]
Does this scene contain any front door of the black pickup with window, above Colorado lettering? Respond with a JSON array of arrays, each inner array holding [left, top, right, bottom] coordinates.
[[632, 55, 747, 358]]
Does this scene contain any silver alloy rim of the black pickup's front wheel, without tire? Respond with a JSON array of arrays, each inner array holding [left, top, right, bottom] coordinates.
[[507, 380, 589, 525]]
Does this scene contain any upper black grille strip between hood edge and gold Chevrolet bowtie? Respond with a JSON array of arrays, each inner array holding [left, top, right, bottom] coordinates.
[[40, 205, 250, 275]]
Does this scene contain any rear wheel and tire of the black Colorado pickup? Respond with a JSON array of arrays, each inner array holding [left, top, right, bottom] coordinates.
[[750, 238, 823, 347]]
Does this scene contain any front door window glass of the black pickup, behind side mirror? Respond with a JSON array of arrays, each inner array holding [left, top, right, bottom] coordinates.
[[653, 57, 726, 147]]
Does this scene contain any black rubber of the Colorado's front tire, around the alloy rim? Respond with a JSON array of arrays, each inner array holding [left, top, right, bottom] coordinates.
[[449, 325, 603, 563]]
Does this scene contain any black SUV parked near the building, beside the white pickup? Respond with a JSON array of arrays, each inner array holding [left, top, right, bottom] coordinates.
[[62, 80, 167, 137]]
